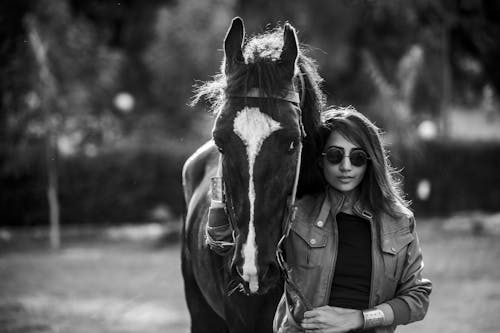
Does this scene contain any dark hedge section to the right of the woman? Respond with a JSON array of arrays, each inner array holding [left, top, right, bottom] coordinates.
[[396, 141, 500, 216]]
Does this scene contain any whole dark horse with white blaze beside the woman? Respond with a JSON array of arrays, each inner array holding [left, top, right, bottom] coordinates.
[[181, 17, 325, 333]]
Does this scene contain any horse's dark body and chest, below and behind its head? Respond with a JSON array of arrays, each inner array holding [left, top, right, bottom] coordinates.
[[182, 142, 282, 332]]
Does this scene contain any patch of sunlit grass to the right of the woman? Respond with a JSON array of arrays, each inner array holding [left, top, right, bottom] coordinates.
[[398, 220, 500, 333]]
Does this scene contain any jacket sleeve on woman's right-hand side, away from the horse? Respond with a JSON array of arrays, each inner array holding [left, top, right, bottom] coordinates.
[[386, 216, 432, 325]]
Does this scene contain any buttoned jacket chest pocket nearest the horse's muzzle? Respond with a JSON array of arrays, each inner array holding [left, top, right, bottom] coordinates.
[[287, 222, 328, 267]]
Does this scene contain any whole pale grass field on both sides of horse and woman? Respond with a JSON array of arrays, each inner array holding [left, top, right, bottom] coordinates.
[[0, 220, 500, 333]]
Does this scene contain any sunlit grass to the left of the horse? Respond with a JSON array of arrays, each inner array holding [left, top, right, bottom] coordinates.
[[0, 235, 188, 332]]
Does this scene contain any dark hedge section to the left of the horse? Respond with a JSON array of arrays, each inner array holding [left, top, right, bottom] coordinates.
[[0, 151, 186, 225]]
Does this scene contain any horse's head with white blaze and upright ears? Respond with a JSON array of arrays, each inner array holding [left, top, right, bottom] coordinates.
[[213, 18, 304, 294]]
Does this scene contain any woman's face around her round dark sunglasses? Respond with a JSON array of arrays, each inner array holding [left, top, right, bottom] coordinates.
[[323, 131, 366, 193]]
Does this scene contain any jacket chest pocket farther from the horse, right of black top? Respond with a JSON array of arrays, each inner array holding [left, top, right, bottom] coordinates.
[[382, 229, 414, 281]]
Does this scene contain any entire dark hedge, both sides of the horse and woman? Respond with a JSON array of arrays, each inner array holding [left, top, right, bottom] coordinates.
[[0, 137, 500, 225]]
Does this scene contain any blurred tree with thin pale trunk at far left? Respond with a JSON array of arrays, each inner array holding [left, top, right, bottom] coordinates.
[[2, 0, 129, 231]]
